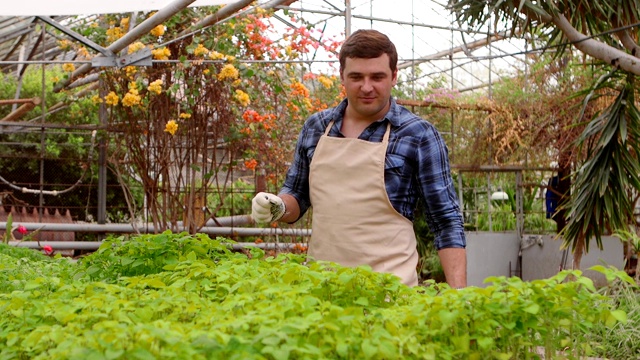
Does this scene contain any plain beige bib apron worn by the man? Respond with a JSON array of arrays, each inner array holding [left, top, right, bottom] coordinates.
[[308, 121, 418, 286]]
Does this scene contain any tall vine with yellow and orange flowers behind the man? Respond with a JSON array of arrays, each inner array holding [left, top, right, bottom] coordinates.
[[78, 5, 348, 230]]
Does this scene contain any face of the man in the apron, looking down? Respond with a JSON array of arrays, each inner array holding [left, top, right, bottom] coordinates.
[[340, 54, 398, 121]]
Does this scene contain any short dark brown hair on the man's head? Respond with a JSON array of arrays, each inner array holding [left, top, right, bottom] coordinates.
[[338, 29, 398, 72]]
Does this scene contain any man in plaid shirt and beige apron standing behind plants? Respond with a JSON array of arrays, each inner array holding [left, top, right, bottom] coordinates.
[[252, 30, 467, 288]]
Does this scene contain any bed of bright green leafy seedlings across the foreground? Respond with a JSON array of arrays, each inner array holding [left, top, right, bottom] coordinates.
[[0, 233, 630, 359]]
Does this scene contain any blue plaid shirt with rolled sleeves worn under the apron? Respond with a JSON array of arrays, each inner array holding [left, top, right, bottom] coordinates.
[[281, 99, 466, 250]]
